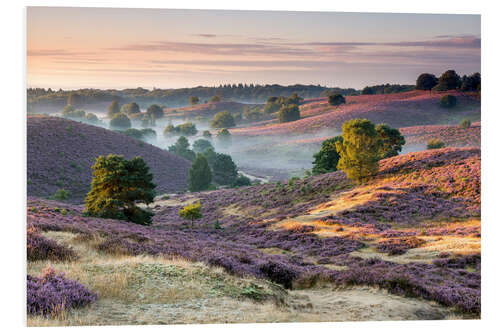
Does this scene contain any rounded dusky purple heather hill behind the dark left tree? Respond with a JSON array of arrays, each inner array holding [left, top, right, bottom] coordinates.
[[27, 116, 190, 202]]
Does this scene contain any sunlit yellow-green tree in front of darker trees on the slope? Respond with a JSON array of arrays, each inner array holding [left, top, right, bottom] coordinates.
[[335, 119, 382, 182]]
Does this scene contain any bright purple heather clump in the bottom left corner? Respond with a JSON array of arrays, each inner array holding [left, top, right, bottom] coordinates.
[[27, 267, 97, 316]]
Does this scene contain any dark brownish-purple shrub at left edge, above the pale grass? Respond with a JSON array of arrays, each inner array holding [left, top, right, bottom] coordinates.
[[26, 227, 77, 261]]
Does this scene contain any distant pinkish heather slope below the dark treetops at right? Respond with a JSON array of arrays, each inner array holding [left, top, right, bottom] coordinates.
[[231, 91, 481, 136]]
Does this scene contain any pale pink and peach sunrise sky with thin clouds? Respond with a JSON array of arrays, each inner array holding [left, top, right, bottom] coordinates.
[[26, 7, 481, 89]]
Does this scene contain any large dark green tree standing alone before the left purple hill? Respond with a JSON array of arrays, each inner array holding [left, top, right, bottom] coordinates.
[[85, 154, 156, 225]]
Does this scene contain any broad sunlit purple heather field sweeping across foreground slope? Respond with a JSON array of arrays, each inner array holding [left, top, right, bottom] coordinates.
[[27, 148, 481, 317]]
